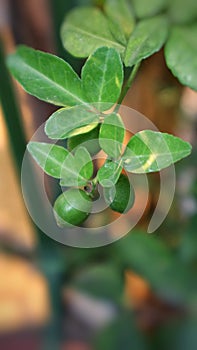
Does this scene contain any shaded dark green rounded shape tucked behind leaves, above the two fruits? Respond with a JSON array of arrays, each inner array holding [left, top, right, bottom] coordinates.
[[67, 124, 101, 156]]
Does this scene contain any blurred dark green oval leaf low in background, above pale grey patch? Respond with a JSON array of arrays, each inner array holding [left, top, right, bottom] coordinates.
[[71, 263, 124, 302]]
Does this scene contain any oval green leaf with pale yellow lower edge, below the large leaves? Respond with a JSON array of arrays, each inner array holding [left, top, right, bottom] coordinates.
[[45, 106, 99, 140]]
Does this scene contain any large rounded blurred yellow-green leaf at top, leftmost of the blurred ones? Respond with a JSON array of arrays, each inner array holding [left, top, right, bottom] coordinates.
[[61, 7, 125, 57]]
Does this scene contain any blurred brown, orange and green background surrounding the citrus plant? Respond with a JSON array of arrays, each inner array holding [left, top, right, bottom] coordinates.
[[0, 0, 197, 350]]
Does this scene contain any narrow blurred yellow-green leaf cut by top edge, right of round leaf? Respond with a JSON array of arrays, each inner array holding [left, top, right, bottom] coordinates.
[[104, 0, 135, 40]]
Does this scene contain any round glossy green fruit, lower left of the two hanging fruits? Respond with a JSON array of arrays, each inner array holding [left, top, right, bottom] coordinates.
[[53, 188, 92, 227]]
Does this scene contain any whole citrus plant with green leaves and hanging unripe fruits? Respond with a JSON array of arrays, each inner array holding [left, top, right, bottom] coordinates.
[[5, 0, 194, 226]]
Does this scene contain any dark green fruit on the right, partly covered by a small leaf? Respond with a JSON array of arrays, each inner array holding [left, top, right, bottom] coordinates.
[[103, 174, 135, 213]]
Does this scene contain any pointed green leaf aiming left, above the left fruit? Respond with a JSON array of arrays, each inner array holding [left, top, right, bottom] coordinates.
[[27, 142, 69, 179]]
